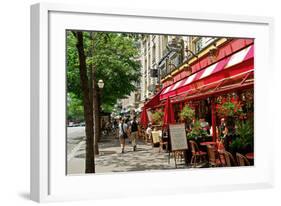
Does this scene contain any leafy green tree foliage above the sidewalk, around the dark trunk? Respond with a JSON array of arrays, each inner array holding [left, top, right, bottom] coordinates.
[[67, 32, 140, 116]]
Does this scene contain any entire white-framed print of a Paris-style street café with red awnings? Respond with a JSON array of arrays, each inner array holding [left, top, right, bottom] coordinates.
[[31, 3, 274, 202]]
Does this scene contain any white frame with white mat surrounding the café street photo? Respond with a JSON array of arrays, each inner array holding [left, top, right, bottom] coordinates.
[[31, 3, 275, 202]]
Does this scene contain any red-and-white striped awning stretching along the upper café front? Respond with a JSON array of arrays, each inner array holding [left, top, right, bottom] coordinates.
[[160, 45, 254, 100]]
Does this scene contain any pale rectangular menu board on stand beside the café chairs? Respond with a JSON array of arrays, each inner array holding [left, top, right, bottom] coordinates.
[[169, 124, 188, 151]]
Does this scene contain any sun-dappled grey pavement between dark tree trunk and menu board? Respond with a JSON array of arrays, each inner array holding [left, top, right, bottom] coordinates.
[[96, 140, 175, 173]]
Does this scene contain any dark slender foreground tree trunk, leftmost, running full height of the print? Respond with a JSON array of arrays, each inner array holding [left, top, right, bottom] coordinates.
[[74, 32, 95, 173]]
